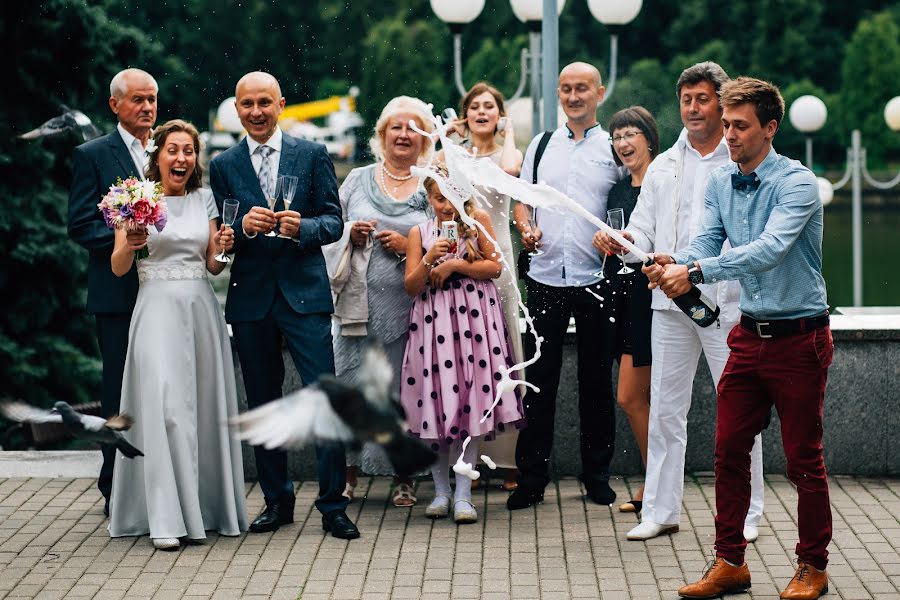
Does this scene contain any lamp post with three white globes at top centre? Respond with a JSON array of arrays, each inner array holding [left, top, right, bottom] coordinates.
[[430, 0, 643, 134]]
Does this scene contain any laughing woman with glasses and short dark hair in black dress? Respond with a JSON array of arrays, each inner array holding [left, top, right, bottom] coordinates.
[[605, 106, 659, 512]]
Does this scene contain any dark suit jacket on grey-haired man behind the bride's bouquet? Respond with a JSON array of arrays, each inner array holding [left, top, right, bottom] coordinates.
[[69, 130, 141, 314]]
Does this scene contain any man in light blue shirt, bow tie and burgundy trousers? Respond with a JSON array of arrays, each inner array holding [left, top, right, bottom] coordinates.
[[644, 77, 834, 599]]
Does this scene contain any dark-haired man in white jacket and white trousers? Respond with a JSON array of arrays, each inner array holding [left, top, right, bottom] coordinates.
[[595, 62, 764, 542]]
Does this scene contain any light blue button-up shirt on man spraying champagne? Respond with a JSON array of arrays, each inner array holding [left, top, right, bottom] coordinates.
[[673, 148, 828, 319]]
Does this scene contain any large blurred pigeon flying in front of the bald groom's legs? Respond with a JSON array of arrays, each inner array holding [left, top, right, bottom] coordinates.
[[232, 344, 437, 477]]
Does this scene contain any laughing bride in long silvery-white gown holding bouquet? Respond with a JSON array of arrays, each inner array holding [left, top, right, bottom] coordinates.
[[109, 120, 247, 549]]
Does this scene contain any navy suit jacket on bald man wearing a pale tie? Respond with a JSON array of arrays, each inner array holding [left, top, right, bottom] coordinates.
[[209, 134, 344, 323]]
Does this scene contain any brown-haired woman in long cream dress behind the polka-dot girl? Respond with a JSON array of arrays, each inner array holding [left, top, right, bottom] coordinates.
[[455, 82, 523, 491]]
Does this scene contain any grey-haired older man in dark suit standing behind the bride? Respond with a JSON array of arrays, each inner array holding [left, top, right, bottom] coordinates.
[[69, 69, 159, 516]]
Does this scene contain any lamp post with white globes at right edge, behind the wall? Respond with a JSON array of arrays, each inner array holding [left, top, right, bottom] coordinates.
[[788, 96, 900, 306]]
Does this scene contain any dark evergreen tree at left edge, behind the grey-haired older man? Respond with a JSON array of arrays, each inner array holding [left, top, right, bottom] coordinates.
[[0, 0, 156, 404]]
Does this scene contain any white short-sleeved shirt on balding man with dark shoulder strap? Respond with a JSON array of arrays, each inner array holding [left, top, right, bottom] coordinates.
[[519, 124, 622, 287]]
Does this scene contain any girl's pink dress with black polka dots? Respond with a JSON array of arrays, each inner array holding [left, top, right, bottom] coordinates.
[[400, 219, 525, 450]]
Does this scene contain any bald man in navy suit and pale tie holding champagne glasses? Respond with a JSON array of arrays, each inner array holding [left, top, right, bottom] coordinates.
[[209, 72, 359, 539]]
